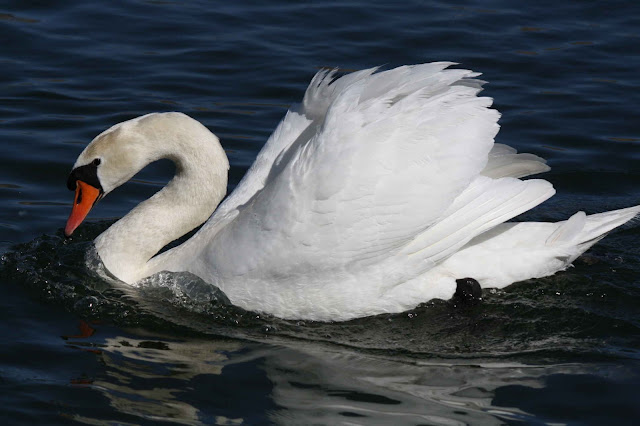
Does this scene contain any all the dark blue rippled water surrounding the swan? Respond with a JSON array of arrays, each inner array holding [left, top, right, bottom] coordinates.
[[0, 0, 640, 425]]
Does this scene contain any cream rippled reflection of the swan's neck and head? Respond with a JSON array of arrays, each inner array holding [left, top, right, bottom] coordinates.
[[71, 333, 244, 425]]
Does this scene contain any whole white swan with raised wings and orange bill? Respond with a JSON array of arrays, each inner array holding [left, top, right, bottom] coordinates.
[[65, 62, 640, 321]]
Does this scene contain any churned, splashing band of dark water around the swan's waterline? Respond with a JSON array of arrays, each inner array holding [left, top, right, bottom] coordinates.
[[0, 223, 640, 359]]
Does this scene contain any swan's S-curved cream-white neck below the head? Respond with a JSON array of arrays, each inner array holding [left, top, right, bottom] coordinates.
[[95, 116, 229, 283]]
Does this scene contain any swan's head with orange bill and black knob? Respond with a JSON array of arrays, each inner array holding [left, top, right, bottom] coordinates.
[[64, 113, 178, 237]]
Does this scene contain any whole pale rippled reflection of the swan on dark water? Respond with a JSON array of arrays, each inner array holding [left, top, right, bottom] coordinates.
[[63, 328, 637, 425]]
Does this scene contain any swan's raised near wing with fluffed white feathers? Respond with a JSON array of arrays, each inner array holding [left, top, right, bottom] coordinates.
[[198, 63, 520, 279]]
